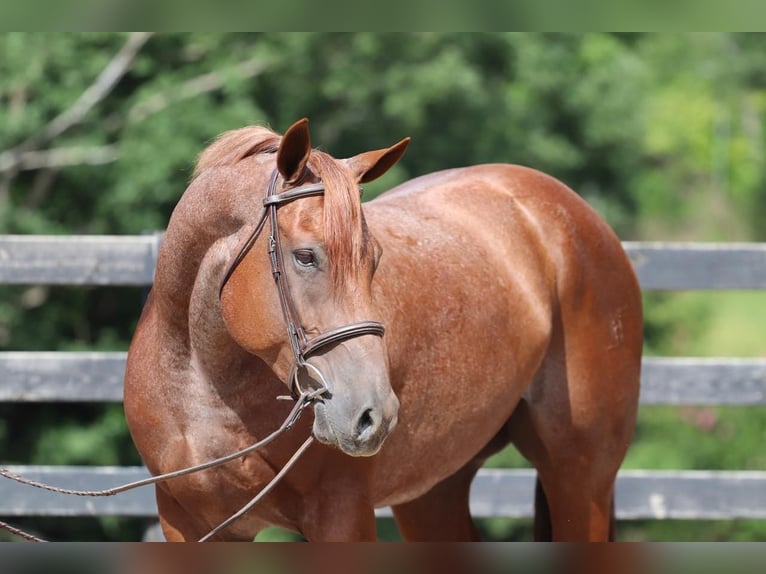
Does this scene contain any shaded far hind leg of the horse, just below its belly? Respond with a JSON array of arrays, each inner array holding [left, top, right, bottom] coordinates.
[[393, 463, 480, 542]]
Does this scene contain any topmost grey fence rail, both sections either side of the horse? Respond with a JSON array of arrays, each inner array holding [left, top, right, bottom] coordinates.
[[0, 237, 766, 291]]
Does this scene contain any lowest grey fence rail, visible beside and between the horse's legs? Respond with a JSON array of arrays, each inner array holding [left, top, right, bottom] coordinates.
[[0, 466, 766, 520]]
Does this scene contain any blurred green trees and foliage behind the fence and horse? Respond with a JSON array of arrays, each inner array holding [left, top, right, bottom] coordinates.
[[0, 33, 766, 540]]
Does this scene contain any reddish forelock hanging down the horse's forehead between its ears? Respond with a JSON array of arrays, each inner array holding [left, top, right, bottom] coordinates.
[[308, 150, 365, 292]]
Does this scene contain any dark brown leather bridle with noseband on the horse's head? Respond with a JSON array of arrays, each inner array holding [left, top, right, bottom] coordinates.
[[218, 169, 385, 398]]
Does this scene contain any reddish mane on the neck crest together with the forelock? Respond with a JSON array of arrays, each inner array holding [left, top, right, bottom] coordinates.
[[192, 126, 366, 293]]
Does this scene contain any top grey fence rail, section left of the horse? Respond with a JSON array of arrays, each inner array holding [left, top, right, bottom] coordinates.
[[0, 235, 160, 285]]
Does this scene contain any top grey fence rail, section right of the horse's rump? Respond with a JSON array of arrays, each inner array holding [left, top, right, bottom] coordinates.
[[623, 242, 766, 291]]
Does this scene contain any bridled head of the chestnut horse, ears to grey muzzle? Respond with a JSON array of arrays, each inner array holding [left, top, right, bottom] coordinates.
[[221, 120, 409, 456]]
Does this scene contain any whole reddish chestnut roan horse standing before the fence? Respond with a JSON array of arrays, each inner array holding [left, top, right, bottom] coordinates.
[[124, 119, 642, 541]]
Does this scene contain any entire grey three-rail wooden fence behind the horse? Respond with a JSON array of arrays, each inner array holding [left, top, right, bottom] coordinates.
[[0, 235, 766, 536]]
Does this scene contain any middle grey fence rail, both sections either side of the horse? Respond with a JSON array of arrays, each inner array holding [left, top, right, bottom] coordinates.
[[0, 352, 766, 406]]
